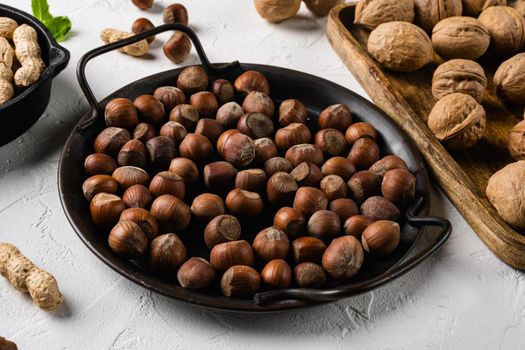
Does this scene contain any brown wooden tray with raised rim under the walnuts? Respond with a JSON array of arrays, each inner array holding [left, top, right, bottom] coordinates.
[[327, 3, 525, 270]]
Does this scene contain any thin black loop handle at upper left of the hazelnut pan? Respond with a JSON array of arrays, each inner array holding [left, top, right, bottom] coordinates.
[[77, 23, 240, 132]]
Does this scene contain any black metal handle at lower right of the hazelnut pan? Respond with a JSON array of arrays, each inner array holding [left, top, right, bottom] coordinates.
[[254, 197, 451, 304]]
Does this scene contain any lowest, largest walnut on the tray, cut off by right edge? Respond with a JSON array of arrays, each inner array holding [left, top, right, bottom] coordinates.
[[486, 160, 525, 228]]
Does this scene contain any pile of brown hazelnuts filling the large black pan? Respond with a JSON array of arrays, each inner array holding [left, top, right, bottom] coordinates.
[[83, 66, 416, 297]]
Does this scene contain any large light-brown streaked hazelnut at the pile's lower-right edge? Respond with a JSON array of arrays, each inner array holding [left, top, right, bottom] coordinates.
[[322, 236, 365, 280]]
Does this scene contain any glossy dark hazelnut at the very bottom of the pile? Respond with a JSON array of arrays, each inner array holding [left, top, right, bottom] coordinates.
[[221, 265, 261, 298]]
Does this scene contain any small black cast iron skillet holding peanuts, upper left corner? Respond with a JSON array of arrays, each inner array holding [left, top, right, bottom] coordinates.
[[0, 4, 69, 146]]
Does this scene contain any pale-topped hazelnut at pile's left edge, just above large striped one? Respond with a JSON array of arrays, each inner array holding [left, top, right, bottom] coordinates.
[[89, 193, 126, 227]]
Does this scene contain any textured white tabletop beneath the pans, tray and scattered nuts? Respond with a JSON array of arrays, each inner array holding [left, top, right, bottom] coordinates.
[[0, 0, 525, 350]]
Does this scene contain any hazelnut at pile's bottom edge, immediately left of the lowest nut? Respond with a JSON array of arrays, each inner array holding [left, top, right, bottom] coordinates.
[[177, 256, 215, 289]]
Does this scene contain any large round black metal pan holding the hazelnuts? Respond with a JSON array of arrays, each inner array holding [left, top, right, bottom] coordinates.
[[58, 24, 451, 312]]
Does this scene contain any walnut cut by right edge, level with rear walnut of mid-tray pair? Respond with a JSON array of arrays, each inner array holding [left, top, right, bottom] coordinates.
[[494, 53, 525, 104]]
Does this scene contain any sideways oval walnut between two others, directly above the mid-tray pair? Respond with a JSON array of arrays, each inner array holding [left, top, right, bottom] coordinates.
[[432, 16, 490, 60]]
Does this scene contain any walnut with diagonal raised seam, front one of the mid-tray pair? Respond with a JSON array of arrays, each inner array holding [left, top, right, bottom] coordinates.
[[428, 93, 486, 151]]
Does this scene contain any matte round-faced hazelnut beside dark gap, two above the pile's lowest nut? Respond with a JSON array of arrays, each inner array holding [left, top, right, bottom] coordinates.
[[204, 214, 241, 248]]
